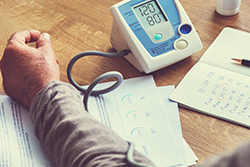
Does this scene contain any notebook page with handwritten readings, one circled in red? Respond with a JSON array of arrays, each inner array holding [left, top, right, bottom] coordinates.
[[170, 63, 250, 127]]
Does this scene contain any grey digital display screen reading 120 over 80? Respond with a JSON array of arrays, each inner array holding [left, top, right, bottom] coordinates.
[[133, 0, 168, 29]]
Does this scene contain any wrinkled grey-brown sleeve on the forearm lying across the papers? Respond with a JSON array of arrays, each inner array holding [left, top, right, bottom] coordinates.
[[29, 81, 154, 167]]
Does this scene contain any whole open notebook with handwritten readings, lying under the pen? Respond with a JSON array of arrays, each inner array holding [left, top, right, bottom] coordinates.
[[170, 27, 250, 127]]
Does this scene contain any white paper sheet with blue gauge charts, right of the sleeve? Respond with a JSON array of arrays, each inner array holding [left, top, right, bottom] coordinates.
[[88, 76, 195, 166]]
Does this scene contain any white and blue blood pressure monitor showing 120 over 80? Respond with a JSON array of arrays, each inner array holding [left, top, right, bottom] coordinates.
[[110, 0, 202, 73]]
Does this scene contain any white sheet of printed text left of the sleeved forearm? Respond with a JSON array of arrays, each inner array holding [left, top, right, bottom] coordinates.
[[0, 95, 53, 167]]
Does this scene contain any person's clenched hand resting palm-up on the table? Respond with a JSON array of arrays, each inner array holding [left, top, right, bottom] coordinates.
[[0, 30, 60, 109]]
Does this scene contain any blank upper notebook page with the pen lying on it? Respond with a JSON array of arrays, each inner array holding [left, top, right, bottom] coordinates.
[[199, 27, 250, 76]]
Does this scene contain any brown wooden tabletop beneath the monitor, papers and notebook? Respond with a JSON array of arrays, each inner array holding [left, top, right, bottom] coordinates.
[[0, 0, 250, 165]]
